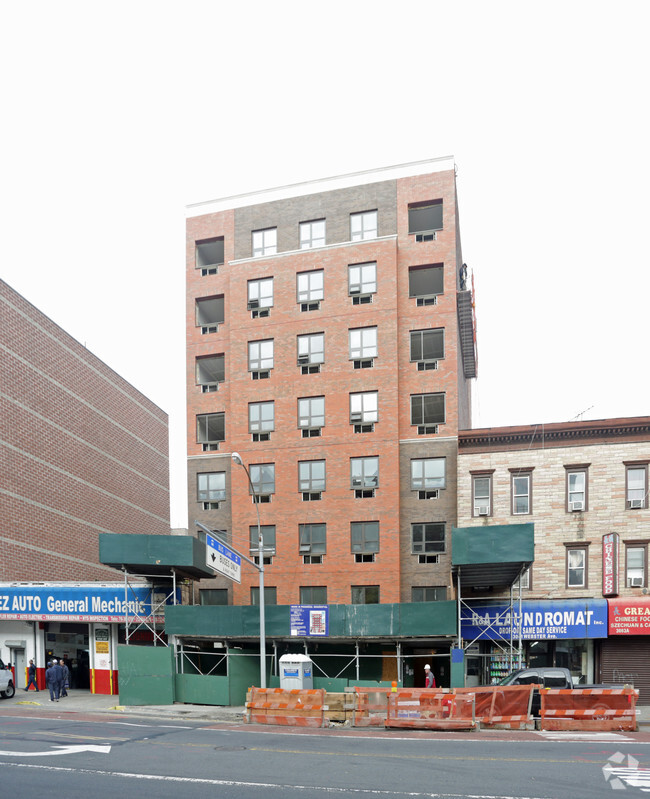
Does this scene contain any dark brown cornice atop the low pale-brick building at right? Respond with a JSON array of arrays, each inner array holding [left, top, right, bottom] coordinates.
[[458, 416, 650, 453]]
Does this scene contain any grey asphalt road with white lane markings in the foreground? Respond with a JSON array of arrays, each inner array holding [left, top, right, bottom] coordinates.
[[0, 715, 650, 799]]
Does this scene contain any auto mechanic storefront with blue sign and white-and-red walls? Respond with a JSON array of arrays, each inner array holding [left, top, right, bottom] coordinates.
[[0, 583, 165, 694]]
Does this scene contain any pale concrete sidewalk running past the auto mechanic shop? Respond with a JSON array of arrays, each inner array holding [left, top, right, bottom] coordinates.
[[8, 690, 650, 732]]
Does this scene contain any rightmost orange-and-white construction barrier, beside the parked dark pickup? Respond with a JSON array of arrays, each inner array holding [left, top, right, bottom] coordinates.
[[540, 687, 639, 732]]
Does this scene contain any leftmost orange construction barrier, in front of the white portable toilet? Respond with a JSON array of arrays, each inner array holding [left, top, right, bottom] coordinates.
[[245, 688, 329, 727]]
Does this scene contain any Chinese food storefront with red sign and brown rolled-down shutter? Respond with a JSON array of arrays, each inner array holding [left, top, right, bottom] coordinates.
[[600, 597, 650, 704]]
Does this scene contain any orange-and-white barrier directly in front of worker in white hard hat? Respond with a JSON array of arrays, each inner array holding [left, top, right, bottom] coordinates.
[[386, 688, 477, 730]]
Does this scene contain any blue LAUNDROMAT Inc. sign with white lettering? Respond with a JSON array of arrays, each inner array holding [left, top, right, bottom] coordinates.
[[460, 599, 607, 641]]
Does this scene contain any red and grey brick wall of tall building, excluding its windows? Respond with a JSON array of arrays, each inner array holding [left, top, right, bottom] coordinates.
[[186, 160, 470, 604]]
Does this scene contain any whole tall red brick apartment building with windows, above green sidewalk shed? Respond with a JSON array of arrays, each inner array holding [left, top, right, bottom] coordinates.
[[187, 158, 476, 605]]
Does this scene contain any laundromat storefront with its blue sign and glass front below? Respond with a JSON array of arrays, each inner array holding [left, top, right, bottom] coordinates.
[[461, 599, 607, 685]]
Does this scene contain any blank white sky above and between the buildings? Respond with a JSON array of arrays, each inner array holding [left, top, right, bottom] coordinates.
[[0, 0, 650, 527]]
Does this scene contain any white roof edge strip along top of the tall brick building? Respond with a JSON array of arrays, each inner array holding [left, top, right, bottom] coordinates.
[[185, 155, 455, 219]]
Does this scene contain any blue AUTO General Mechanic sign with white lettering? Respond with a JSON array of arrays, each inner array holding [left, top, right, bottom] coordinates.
[[0, 585, 165, 622]]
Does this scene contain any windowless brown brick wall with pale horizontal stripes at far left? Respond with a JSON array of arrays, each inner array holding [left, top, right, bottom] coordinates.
[[0, 281, 170, 581]]
